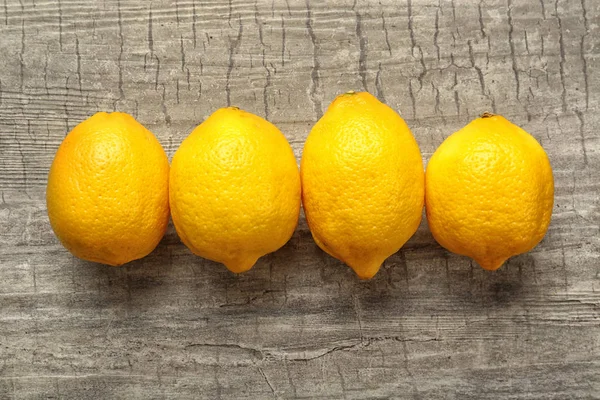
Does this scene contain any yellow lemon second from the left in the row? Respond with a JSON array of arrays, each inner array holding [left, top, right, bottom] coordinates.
[[169, 107, 300, 273]]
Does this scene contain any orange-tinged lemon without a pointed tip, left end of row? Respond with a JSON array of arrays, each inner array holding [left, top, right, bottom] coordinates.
[[46, 112, 169, 266]]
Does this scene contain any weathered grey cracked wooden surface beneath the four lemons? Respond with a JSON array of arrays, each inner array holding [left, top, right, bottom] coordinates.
[[0, 0, 600, 399]]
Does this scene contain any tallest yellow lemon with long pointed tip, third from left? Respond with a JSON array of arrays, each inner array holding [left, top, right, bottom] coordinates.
[[300, 92, 424, 279]]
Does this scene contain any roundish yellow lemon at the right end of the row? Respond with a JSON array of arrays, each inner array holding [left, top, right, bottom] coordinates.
[[425, 114, 554, 270]]
